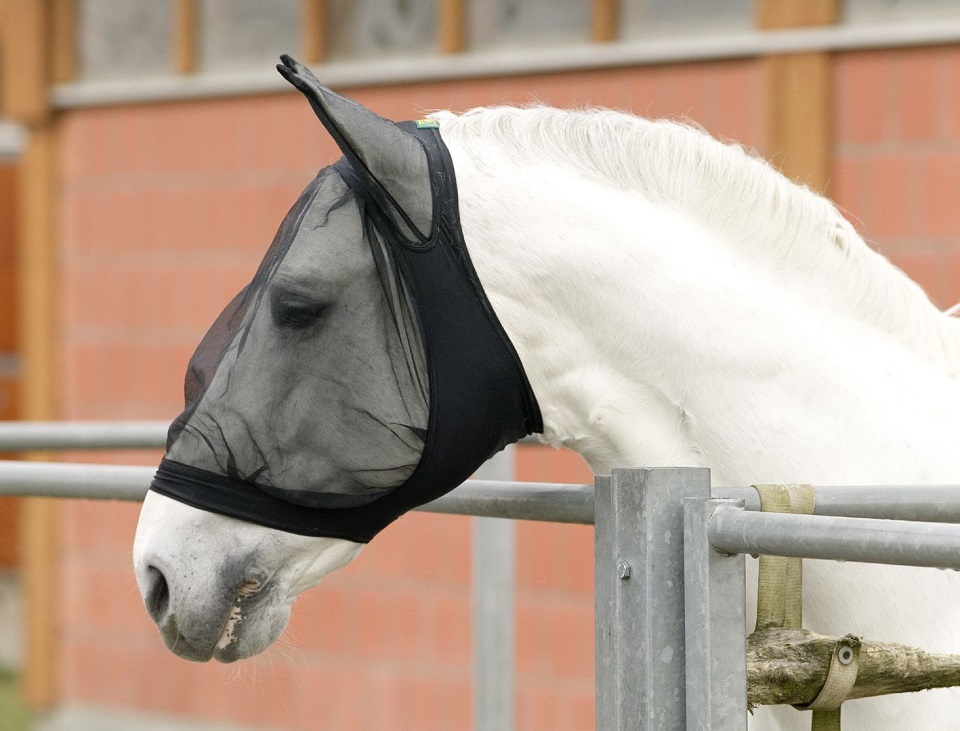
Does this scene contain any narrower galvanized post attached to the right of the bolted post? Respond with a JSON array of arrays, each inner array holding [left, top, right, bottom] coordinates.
[[683, 498, 747, 731]]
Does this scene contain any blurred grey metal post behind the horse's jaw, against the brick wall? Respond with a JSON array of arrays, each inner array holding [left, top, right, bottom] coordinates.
[[473, 446, 516, 731]]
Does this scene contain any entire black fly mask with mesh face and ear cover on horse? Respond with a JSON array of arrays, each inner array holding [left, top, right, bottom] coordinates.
[[151, 57, 542, 542]]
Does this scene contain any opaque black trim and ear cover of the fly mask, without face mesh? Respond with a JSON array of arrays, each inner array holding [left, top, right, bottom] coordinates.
[[151, 56, 543, 543]]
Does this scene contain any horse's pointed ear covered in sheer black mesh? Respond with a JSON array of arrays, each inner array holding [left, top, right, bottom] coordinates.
[[277, 55, 433, 239]]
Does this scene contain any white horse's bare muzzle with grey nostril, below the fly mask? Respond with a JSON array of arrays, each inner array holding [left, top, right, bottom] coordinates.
[[133, 492, 363, 662]]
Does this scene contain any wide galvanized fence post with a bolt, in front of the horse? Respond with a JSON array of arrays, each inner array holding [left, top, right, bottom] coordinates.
[[594, 467, 710, 731]]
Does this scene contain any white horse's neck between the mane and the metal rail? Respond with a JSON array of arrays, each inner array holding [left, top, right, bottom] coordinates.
[[448, 136, 960, 492]]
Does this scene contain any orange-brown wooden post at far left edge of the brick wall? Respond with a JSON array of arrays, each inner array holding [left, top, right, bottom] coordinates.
[[0, 0, 64, 708]]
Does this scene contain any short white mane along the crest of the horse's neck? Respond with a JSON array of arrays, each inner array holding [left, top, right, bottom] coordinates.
[[434, 106, 960, 376]]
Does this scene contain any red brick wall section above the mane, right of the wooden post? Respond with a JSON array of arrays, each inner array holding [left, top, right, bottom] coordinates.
[[830, 47, 960, 307]]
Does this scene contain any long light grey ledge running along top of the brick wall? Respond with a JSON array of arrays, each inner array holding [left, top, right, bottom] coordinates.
[[52, 17, 960, 109]]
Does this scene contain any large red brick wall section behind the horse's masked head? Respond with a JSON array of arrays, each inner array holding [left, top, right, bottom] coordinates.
[[59, 61, 763, 731]]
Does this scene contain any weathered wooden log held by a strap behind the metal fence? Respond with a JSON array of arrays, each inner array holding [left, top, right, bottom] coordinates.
[[747, 628, 960, 708]]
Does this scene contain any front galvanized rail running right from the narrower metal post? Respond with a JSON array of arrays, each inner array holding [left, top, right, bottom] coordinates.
[[708, 507, 960, 569]]
